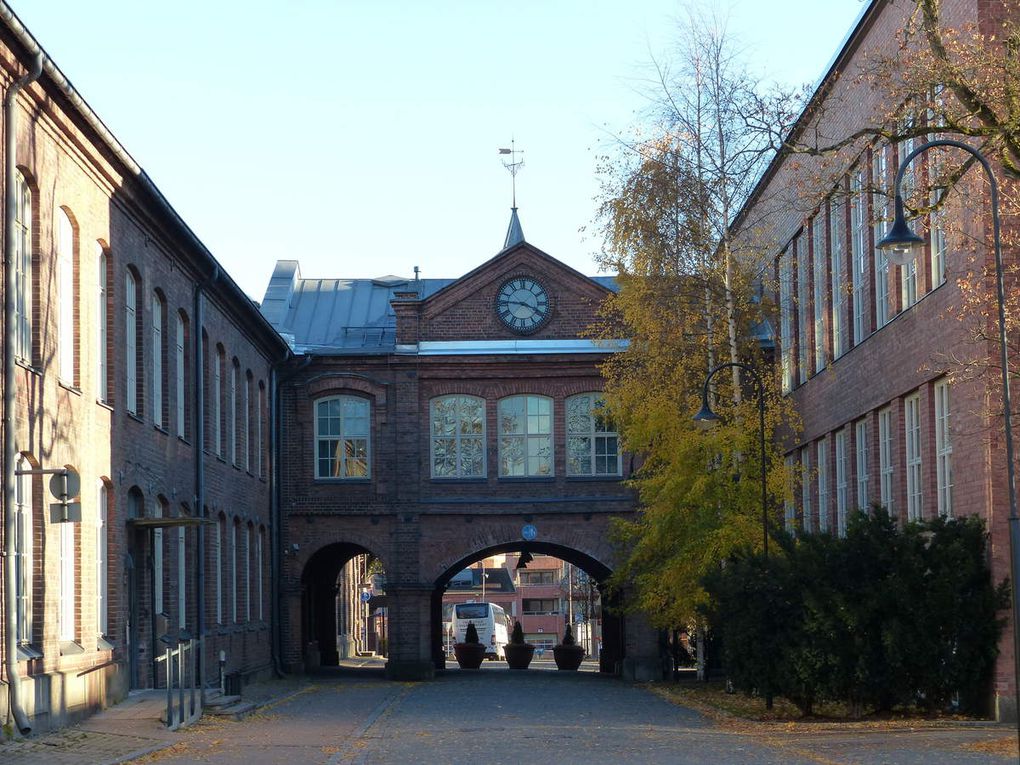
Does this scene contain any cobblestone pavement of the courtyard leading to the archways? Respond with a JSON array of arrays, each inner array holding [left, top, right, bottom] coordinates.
[[0, 664, 1015, 765]]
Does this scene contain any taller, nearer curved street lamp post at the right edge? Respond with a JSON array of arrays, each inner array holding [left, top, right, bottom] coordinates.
[[878, 139, 1020, 736]]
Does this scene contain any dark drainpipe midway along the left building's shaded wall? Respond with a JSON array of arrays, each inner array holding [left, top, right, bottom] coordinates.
[[192, 265, 219, 704]]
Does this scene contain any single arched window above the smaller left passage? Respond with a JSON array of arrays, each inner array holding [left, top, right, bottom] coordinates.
[[315, 396, 370, 478]]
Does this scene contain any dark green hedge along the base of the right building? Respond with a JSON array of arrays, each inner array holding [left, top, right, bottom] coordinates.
[[705, 507, 1009, 716]]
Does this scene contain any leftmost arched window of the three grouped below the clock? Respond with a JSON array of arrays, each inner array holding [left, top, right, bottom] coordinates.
[[429, 395, 486, 478]]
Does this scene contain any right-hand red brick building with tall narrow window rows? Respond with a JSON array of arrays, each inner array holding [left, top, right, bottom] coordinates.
[[736, 0, 1016, 719]]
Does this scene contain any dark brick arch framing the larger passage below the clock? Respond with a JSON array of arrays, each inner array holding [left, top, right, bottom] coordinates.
[[430, 540, 625, 674]]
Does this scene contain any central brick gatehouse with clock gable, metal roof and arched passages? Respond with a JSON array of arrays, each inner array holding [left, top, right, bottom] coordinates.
[[262, 216, 661, 677]]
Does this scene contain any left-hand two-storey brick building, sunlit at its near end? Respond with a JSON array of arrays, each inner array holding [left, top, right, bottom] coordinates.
[[0, 5, 288, 729]]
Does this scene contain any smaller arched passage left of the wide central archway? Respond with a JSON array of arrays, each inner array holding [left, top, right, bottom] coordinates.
[[301, 542, 388, 669]]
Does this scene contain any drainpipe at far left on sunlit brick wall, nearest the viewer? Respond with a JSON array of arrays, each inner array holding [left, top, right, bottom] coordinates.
[[3, 47, 43, 734]]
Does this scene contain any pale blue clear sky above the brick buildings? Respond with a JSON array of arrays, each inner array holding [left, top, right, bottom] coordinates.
[[9, 0, 865, 301]]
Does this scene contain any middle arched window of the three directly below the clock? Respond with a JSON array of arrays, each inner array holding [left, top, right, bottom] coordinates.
[[499, 396, 553, 477]]
